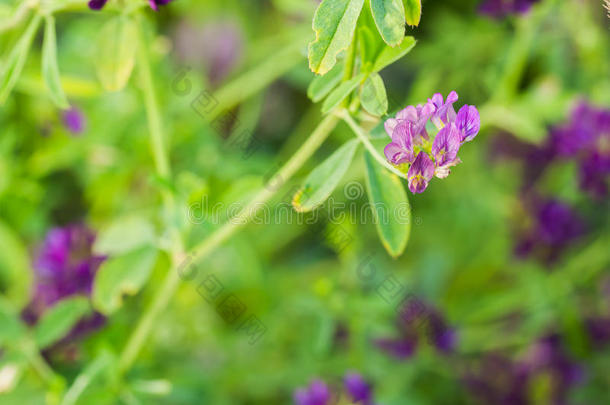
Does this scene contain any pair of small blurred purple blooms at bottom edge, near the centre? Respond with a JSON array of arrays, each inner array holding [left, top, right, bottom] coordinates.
[[294, 372, 373, 405]]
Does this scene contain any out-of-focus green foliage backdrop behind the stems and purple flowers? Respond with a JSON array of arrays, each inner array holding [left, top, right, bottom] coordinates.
[[0, 0, 610, 405]]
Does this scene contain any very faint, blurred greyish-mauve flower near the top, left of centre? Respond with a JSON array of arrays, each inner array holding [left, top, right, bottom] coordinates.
[[174, 21, 244, 86]]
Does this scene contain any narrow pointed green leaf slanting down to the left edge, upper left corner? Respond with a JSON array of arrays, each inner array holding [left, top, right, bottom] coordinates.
[[0, 14, 41, 104]]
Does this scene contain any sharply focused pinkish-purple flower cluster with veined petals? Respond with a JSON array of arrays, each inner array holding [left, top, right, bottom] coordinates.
[[384, 91, 481, 193]]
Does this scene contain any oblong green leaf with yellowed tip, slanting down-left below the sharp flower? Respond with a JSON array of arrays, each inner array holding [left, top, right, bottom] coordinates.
[[292, 139, 359, 212]]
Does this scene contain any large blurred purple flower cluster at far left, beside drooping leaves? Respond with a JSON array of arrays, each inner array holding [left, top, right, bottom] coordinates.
[[23, 224, 105, 338]]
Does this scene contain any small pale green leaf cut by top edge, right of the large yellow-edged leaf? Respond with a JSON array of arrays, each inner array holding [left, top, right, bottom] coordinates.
[[371, 0, 405, 46]]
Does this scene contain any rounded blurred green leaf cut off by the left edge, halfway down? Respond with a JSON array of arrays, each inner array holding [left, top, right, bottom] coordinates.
[[0, 222, 32, 308]]
